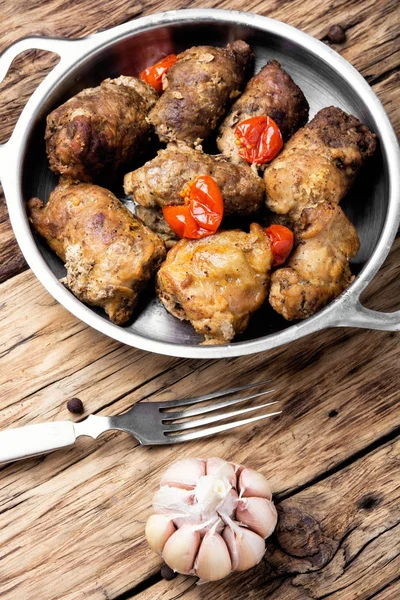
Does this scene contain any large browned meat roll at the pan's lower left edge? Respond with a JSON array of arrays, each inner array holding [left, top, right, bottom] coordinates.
[[29, 183, 166, 325]]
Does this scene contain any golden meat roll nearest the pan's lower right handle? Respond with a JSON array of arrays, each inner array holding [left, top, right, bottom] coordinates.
[[269, 202, 360, 321]]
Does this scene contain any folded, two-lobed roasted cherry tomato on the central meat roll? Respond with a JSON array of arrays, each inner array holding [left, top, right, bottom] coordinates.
[[163, 175, 224, 239]]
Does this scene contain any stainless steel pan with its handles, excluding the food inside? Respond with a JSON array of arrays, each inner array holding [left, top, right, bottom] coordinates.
[[0, 9, 400, 358]]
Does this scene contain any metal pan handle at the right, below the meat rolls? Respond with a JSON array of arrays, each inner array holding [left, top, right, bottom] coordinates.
[[331, 298, 400, 331]]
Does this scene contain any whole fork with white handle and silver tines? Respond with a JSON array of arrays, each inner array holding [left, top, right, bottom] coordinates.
[[0, 379, 282, 463]]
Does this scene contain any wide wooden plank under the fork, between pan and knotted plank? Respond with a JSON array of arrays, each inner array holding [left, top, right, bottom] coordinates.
[[0, 245, 399, 600]]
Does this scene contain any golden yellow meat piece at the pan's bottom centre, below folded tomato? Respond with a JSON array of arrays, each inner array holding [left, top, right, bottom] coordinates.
[[156, 223, 272, 344]]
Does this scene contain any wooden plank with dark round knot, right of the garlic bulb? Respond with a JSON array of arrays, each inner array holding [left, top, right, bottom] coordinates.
[[132, 441, 400, 600]]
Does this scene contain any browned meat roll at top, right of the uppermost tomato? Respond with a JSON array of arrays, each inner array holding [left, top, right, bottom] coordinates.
[[150, 40, 253, 146]]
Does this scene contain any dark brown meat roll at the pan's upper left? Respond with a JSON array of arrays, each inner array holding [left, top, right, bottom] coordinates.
[[45, 76, 158, 182]]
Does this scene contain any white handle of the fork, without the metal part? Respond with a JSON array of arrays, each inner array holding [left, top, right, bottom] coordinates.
[[0, 421, 76, 463]]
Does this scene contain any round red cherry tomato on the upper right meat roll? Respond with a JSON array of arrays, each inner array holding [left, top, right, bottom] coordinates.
[[235, 116, 283, 165]]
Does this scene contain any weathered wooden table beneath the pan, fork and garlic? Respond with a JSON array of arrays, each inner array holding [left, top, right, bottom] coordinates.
[[0, 0, 400, 600]]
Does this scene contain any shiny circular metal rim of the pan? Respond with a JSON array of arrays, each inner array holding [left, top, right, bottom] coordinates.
[[0, 9, 400, 358]]
